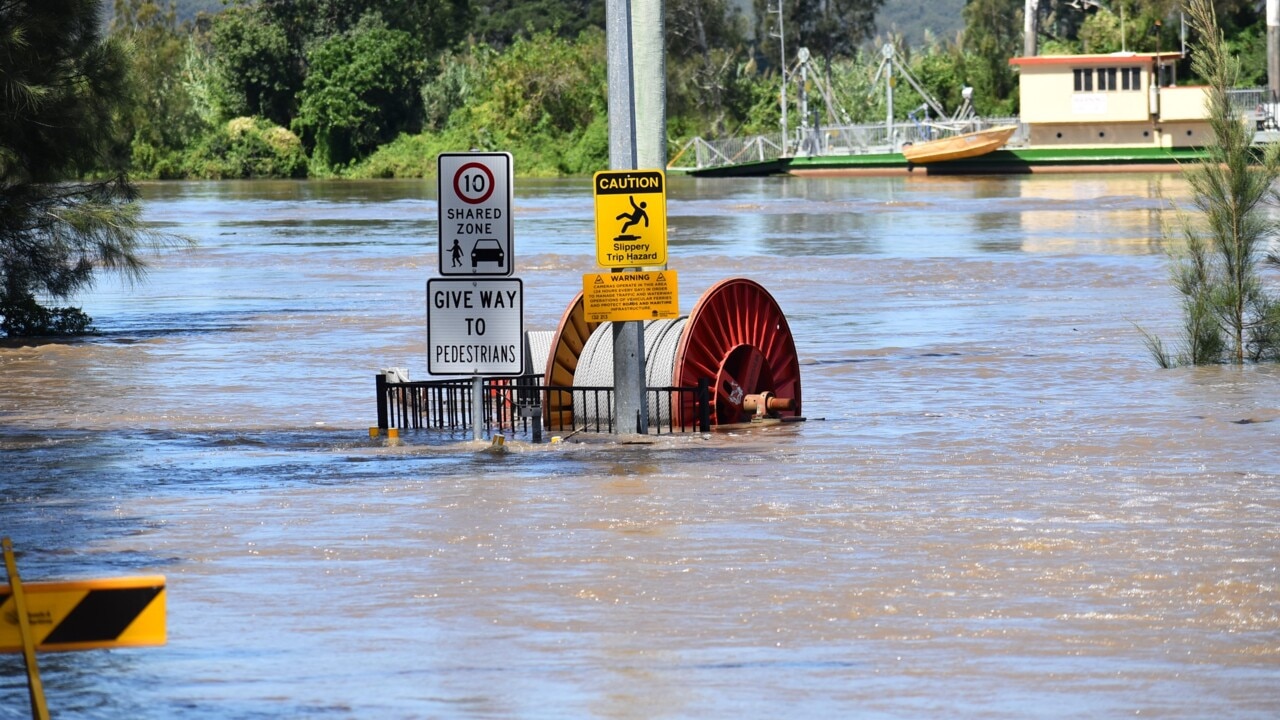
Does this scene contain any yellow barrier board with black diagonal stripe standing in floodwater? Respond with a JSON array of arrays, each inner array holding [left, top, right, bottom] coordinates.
[[0, 575, 168, 652]]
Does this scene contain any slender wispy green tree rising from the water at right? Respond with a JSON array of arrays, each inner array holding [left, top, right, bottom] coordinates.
[[1144, 0, 1280, 368]]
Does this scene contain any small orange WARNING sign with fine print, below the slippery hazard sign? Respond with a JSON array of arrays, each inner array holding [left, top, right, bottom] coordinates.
[[582, 270, 680, 323]]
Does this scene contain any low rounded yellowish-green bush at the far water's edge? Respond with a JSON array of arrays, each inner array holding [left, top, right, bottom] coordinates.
[[183, 118, 307, 179]]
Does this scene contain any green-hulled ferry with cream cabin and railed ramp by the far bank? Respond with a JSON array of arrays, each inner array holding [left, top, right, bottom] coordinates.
[[668, 49, 1275, 177]]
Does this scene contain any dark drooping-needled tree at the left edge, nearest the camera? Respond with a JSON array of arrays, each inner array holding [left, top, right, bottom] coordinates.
[[0, 0, 181, 336]]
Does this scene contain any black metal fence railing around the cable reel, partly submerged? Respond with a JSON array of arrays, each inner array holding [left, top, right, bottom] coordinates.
[[375, 373, 710, 442]]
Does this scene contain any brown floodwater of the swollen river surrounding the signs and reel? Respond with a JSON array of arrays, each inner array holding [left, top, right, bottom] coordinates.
[[0, 167, 1280, 720]]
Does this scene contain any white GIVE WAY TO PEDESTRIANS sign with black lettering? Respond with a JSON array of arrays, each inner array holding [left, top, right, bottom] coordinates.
[[426, 278, 525, 375]]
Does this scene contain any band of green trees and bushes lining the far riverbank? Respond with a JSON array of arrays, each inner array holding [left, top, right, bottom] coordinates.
[[80, 0, 1280, 178]]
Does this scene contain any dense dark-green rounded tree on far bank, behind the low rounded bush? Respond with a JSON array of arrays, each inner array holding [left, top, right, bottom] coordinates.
[[294, 13, 422, 169]]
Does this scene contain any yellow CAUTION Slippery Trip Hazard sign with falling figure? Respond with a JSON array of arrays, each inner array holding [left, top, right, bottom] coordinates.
[[591, 170, 667, 268]]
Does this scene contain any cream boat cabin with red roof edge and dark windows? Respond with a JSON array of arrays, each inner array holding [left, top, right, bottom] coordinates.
[[1009, 53, 1212, 147]]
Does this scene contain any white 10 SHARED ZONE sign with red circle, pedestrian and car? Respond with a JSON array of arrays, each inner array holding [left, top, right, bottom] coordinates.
[[436, 152, 515, 275]]
